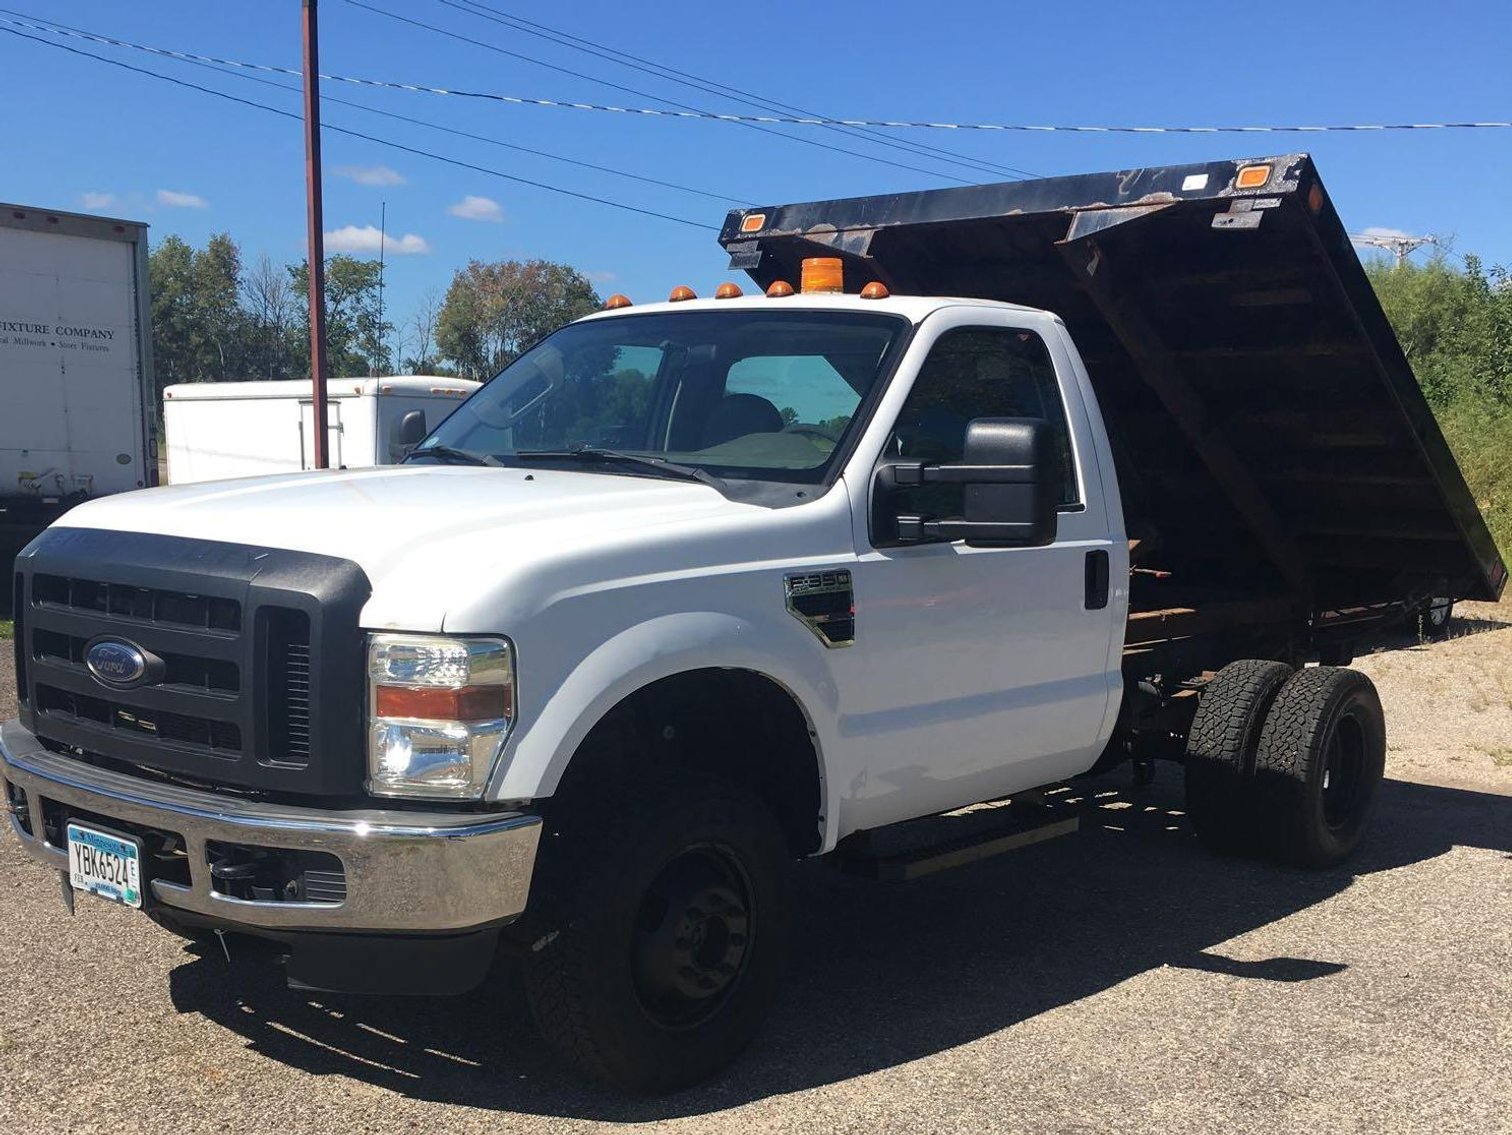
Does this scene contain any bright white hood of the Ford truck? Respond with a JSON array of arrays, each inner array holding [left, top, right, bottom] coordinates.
[[57, 465, 770, 630]]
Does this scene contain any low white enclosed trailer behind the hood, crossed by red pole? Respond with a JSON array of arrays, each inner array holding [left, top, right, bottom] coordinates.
[[163, 375, 478, 485]]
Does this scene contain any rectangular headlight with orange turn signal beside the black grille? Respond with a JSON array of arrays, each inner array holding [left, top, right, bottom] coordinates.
[[367, 635, 514, 799]]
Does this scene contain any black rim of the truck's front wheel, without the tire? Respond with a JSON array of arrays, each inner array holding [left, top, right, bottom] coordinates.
[[631, 845, 754, 1028]]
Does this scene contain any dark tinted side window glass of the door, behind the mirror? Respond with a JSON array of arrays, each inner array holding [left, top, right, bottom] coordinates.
[[886, 326, 1081, 517]]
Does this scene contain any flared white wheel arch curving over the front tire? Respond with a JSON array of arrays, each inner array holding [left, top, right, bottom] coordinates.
[[488, 611, 838, 843]]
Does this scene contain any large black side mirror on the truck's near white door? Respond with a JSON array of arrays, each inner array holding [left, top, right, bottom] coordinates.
[[872, 417, 1061, 547]]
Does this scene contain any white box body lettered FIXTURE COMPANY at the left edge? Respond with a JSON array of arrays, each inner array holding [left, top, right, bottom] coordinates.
[[0, 204, 157, 564]]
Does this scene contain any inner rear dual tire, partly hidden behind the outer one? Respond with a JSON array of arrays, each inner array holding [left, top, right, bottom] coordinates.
[[1185, 659, 1293, 855]]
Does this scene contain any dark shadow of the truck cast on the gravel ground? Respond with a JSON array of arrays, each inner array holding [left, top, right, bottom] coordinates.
[[171, 772, 1512, 1123]]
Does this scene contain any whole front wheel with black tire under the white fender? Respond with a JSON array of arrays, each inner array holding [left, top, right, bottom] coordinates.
[[525, 774, 791, 1093]]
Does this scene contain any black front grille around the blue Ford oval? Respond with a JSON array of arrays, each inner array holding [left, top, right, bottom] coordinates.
[[17, 527, 369, 796]]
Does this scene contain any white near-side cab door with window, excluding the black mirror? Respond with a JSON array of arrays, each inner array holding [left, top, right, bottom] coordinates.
[[835, 308, 1126, 828]]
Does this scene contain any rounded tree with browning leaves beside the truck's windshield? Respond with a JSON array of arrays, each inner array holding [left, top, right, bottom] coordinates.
[[435, 260, 602, 379]]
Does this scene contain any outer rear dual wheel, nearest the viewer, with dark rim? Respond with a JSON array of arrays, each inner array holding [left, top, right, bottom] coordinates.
[[1255, 666, 1387, 867]]
